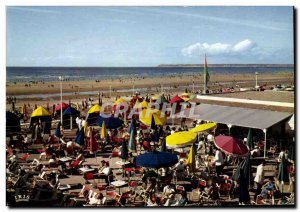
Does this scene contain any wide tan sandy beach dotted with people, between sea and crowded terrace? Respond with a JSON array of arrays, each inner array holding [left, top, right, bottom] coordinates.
[[6, 72, 294, 110]]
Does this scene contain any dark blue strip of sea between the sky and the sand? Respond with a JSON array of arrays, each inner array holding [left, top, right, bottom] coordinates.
[[6, 65, 294, 83]]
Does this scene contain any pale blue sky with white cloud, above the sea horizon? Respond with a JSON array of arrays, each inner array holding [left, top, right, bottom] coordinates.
[[6, 6, 293, 66]]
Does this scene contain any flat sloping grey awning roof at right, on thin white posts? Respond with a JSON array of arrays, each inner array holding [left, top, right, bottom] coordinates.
[[176, 104, 293, 130]]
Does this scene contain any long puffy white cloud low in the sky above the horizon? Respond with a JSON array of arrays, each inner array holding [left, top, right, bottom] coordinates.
[[181, 39, 256, 57]]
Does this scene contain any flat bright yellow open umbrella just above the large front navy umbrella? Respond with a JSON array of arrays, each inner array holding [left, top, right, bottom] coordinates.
[[166, 131, 197, 148]]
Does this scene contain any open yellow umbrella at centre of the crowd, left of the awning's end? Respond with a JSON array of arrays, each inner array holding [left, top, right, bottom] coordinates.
[[139, 109, 167, 126]]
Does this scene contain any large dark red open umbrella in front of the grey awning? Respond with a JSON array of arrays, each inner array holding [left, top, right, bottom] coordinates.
[[215, 135, 249, 156]]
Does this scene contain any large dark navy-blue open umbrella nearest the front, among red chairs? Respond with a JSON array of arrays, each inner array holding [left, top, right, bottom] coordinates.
[[136, 151, 178, 169]]
